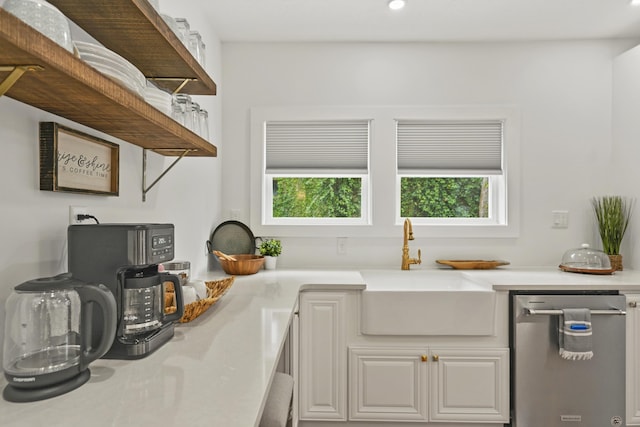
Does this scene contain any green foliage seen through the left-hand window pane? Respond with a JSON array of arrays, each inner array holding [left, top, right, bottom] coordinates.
[[273, 178, 362, 218]]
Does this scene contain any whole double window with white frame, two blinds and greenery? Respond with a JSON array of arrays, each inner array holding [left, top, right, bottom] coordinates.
[[251, 105, 520, 238]]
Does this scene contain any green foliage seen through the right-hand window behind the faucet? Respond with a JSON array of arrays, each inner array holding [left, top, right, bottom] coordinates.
[[400, 177, 489, 218]]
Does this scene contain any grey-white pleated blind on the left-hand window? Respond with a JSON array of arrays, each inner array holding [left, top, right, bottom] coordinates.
[[265, 120, 369, 174]]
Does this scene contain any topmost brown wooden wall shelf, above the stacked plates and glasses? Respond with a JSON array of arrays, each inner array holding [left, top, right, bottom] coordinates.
[[49, 0, 216, 95]]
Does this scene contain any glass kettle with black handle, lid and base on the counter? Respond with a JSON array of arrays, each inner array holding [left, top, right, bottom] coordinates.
[[3, 274, 116, 402]]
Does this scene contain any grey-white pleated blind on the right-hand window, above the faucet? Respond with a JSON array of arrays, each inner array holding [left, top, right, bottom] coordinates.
[[397, 120, 503, 175]]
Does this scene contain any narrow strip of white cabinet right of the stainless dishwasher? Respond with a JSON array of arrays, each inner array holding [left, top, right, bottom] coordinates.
[[626, 294, 640, 426]]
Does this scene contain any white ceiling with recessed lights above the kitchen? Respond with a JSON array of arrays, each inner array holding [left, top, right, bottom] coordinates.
[[196, 0, 640, 42]]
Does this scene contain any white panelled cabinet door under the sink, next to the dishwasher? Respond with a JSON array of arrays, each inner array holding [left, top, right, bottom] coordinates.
[[429, 348, 509, 423]]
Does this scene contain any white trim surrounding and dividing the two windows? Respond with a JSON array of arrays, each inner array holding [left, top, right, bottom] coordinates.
[[248, 105, 520, 239]]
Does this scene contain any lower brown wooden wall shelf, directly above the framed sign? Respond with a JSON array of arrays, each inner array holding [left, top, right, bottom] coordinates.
[[0, 9, 217, 157]]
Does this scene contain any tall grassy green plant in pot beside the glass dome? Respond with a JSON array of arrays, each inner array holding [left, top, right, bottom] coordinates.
[[592, 196, 633, 270]]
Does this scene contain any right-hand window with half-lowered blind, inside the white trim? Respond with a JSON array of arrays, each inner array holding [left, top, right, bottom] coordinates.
[[396, 120, 506, 225]]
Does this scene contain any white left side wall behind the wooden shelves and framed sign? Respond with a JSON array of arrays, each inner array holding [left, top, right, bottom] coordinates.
[[0, 2, 224, 358]]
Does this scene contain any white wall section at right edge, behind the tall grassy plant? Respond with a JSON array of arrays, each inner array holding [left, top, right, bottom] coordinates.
[[609, 46, 640, 269]]
